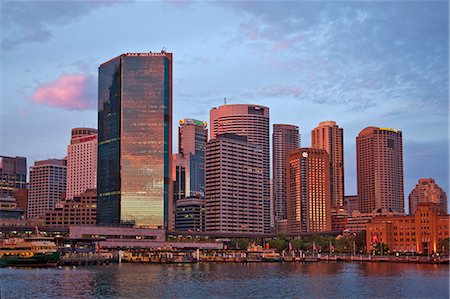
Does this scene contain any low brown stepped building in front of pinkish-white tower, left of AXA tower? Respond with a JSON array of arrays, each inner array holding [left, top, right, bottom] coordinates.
[[45, 189, 97, 227]]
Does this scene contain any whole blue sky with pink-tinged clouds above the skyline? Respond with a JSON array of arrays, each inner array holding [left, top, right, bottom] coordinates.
[[0, 1, 449, 211]]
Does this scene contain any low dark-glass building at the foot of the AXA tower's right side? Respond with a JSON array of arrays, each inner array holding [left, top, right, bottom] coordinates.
[[175, 197, 206, 231]]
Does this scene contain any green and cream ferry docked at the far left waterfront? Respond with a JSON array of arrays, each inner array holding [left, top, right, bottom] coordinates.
[[0, 237, 60, 267]]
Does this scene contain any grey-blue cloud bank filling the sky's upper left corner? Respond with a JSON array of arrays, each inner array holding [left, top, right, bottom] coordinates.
[[0, 1, 124, 50]]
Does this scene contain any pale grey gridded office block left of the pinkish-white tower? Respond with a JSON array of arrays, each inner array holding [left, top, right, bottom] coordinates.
[[27, 159, 67, 219]]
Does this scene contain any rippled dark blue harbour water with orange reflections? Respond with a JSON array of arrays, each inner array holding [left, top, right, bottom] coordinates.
[[0, 262, 449, 299]]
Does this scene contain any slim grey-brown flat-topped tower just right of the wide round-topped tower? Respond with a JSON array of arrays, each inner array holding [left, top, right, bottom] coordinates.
[[272, 124, 301, 225]]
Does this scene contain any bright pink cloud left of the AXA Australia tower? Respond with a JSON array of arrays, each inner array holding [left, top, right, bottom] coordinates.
[[31, 74, 97, 110]]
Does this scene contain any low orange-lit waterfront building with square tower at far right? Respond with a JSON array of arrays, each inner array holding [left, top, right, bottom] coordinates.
[[366, 203, 450, 254]]
